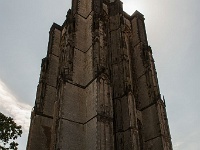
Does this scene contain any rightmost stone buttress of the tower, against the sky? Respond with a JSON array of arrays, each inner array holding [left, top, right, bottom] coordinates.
[[131, 11, 172, 149]]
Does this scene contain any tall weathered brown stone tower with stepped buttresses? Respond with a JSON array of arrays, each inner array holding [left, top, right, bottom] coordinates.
[[27, 0, 172, 150]]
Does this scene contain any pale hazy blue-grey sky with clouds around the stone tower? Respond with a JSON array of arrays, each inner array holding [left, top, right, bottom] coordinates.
[[0, 0, 200, 150]]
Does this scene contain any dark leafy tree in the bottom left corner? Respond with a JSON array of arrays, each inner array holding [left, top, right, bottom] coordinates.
[[0, 112, 22, 150]]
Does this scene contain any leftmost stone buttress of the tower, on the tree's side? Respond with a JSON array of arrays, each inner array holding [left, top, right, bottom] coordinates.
[[27, 24, 61, 150]]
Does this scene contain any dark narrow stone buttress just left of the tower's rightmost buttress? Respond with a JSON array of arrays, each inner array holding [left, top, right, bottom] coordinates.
[[109, 1, 139, 150]]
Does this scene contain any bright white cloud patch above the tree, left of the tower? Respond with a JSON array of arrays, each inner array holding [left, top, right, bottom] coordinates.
[[0, 80, 31, 132]]
